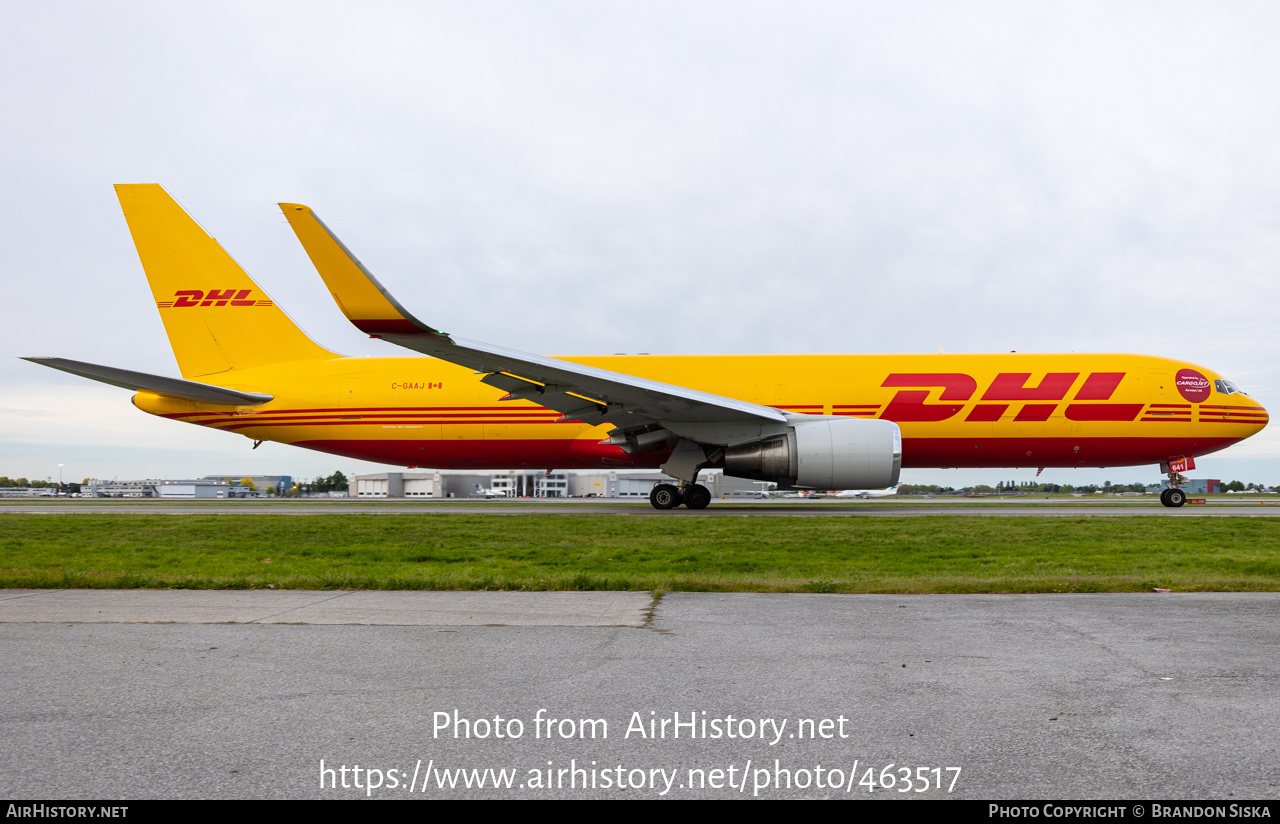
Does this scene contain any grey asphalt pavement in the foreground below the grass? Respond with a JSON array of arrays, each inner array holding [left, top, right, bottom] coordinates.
[[0, 590, 1280, 800]]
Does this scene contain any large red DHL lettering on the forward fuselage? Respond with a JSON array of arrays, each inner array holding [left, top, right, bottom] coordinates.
[[875, 372, 1144, 424]]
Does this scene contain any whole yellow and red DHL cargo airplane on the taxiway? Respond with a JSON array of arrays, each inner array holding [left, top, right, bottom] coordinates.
[[27, 184, 1268, 509]]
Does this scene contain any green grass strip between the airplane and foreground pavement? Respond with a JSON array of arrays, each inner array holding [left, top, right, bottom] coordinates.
[[0, 513, 1280, 592]]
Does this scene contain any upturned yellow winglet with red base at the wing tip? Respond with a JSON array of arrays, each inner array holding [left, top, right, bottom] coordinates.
[[280, 203, 448, 338]]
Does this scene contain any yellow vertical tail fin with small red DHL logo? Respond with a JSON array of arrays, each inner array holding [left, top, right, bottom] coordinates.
[[115, 183, 338, 379]]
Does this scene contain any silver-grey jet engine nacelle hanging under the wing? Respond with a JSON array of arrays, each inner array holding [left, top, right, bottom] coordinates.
[[724, 416, 902, 489]]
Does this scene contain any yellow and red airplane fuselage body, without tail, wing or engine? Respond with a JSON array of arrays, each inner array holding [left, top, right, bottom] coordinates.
[[134, 353, 1268, 468]]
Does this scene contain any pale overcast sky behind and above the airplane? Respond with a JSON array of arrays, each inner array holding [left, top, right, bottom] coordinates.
[[0, 0, 1280, 485]]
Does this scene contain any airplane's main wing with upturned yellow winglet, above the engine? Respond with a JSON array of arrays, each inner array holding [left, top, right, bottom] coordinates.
[[280, 203, 788, 436]]
